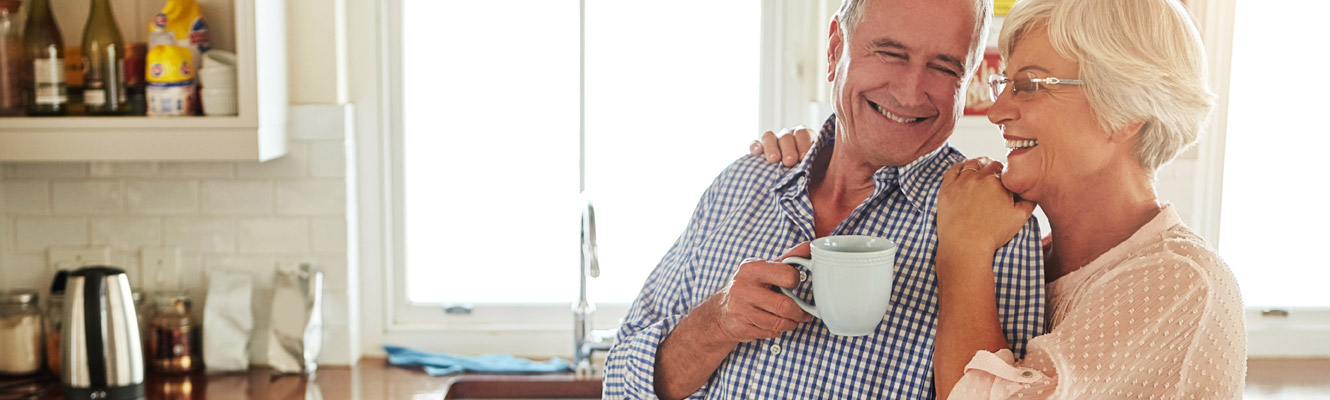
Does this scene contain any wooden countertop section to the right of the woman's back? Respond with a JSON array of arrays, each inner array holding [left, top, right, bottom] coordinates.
[[1244, 359, 1330, 400]]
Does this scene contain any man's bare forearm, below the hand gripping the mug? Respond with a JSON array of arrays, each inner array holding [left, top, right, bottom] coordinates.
[[654, 292, 738, 399]]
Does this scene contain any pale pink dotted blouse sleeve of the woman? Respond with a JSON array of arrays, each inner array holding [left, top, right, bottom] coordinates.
[[951, 255, 1241, 399]]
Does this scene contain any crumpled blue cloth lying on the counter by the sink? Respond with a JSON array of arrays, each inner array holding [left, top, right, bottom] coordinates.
[[383, 346, 572, 376]]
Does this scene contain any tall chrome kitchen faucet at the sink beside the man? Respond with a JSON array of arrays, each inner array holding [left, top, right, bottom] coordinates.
[[573, 193, 614, 376]]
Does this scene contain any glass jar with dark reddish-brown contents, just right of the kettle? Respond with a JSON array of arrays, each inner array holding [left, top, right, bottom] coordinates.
[[148, 292, 202, 373]]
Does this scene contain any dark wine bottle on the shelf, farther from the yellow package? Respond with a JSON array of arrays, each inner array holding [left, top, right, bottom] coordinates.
[[23, 0, 69, 116]]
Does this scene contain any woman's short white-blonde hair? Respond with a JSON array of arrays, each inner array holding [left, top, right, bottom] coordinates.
[[998, 0, 1214, 174]]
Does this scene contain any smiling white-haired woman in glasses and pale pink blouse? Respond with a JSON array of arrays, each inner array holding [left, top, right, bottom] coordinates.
[[755, 0, 1246, 399]]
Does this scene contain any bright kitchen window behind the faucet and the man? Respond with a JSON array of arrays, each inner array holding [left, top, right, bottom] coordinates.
[[362, 0, 803, 356]]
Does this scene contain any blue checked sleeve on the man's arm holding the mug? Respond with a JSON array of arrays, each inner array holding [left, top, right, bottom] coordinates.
[[602, 172, 721, 399]]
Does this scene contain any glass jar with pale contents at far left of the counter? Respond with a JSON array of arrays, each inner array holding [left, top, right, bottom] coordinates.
[[0, 291, 41, 375]]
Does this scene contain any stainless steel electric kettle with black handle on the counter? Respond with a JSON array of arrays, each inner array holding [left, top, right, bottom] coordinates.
[[60, 267, 144, 400]]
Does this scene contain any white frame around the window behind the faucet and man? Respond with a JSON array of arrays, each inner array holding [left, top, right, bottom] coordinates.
[[347, 0, 839, 357]]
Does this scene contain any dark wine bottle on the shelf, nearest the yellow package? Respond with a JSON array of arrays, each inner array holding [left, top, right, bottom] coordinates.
[[82, 0, 129, 116]]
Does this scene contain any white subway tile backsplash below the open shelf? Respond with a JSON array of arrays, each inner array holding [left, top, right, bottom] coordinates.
[[0, 120, 359, 364]]
